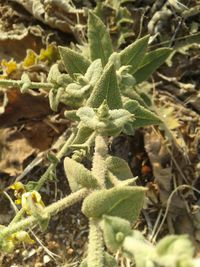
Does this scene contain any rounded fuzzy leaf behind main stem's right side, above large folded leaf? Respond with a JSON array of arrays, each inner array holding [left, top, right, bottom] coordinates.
[[106, 156, 133, 181]]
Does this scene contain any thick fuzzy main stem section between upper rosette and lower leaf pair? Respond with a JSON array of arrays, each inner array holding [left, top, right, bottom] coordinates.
[[92, 135, 108, 188]]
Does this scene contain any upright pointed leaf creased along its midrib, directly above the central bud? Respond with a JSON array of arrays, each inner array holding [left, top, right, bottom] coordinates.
[[87, 64, 122, 109]]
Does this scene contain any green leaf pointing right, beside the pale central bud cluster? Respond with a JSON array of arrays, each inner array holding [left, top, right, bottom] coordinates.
[[124, 100, 162, 128]]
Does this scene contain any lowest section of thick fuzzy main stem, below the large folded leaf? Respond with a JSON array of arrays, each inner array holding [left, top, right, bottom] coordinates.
[[87, 218, 104, 267]]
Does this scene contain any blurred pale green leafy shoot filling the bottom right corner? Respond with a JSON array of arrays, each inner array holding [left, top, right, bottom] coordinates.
[[100, 215, 200, 267]]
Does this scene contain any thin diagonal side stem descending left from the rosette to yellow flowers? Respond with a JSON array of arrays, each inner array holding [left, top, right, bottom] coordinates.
[[9, 130, 75, 226]]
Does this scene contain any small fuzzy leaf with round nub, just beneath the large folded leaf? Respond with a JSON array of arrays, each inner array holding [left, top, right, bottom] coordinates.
[[101, 215, 132, 253]]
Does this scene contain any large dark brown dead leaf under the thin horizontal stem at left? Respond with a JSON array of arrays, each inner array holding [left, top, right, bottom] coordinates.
[[0, 89, 67, 151]]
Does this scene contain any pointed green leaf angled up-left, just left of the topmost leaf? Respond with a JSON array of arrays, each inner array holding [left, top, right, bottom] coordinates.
[[58, 46, 90, 78]]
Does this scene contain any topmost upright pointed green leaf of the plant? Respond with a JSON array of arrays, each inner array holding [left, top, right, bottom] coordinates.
[[88, 12, 112, 66]]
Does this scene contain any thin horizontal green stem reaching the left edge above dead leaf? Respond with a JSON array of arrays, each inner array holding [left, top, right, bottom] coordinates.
[[0, 79, 53, 89]]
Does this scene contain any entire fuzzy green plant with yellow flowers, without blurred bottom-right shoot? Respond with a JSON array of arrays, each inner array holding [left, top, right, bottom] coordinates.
[[0, 8, 197, 267]]
